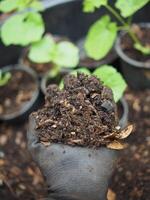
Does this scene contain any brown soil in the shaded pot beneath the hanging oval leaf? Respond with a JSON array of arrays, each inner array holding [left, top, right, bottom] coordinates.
[[77, 39, 117, 69]]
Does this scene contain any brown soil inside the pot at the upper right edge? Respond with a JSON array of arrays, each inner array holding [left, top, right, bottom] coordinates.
[[121, 25, 150, 63]]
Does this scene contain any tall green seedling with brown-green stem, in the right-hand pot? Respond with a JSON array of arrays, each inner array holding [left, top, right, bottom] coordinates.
[[83, 0, 150, 60]]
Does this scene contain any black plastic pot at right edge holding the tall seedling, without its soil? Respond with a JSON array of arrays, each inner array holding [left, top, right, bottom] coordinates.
[[115, 23, 150, 90]]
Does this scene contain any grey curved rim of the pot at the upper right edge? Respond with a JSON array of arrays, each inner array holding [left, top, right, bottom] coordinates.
[[115, 22, 150, 69]]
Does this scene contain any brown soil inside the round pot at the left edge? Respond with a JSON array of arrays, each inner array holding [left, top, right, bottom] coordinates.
[[0, 70, 37, 116]]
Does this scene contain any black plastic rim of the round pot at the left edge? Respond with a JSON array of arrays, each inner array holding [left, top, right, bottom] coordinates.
[[0, 65, 40, 122]]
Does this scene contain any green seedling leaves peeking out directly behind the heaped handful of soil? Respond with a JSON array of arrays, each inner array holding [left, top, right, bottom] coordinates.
[[59, 65, 127, 102]]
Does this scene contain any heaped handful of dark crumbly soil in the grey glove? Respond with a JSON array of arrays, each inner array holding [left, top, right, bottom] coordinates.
[[32, 74, 131, 147]]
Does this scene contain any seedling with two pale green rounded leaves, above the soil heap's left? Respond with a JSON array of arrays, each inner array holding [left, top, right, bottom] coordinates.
[[28, 35, 79, 70]]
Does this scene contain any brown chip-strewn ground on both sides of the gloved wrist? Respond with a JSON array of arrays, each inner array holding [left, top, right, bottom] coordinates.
[[0, 90, 150, 200]]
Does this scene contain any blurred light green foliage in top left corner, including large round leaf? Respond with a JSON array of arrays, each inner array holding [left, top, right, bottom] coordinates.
[[0, 0, 45, 46]]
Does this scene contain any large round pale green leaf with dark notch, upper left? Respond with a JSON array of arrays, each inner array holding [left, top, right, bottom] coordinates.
[[1, 12, 45, 46]]
